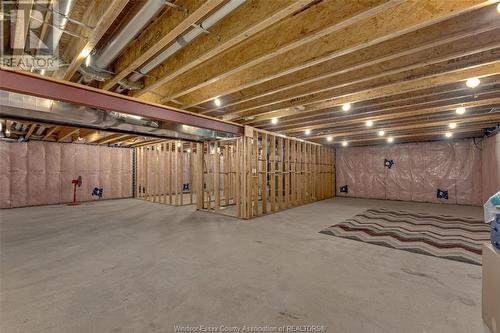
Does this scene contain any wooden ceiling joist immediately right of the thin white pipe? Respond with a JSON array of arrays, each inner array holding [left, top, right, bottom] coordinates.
[[132, 0, 312, 97]]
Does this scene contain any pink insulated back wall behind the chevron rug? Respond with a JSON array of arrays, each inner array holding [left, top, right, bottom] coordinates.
[[336, 139, 484, 205]]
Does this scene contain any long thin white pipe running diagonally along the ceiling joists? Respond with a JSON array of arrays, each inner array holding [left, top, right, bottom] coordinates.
[[126, 0, 245, 83]]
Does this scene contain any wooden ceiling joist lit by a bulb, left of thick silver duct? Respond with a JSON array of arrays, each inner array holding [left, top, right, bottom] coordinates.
[[55, 0, 128, 80]]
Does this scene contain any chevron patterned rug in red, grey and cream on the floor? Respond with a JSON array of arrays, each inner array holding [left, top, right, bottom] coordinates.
[[320, 209, 490, 265]]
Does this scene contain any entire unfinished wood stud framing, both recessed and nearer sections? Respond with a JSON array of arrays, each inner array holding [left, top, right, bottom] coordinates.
[[135, 126, 335, 219]]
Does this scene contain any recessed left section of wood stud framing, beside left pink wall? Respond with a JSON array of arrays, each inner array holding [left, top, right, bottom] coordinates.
[[135, 141, 200, 206]]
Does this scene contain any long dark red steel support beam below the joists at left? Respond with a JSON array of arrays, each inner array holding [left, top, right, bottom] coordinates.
[[0, 67, 244, 135]]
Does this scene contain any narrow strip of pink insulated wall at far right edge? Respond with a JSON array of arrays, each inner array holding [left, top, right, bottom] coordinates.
[[482, 134, 500, 202]]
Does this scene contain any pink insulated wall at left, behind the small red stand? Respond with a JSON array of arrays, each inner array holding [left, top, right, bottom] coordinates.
[[0, 141, 132, 208]]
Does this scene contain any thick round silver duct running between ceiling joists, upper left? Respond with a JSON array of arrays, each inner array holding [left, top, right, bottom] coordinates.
[[94, 0, 169, 69]]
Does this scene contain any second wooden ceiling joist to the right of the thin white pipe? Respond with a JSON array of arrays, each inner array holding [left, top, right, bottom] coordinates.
[[149, 0, 402, 101]]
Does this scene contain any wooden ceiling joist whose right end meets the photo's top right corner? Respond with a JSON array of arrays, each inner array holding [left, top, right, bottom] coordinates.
[[201, 6, 500, 115]]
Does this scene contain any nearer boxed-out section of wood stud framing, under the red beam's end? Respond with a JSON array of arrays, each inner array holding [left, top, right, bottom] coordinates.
[[197, 126, 335, 219]]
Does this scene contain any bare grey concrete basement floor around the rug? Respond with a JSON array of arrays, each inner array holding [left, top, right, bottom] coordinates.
[[0, 198, 487, 333]]
